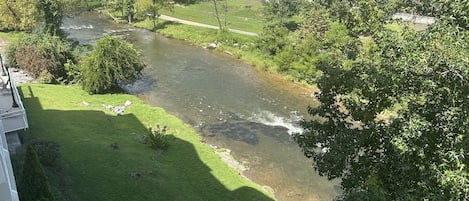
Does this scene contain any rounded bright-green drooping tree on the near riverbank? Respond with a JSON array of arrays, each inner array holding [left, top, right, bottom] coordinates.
[[81, 36, 144, 94]]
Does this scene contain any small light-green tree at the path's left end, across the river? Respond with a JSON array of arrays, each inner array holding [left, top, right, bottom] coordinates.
[[135, 0, 174, 30]]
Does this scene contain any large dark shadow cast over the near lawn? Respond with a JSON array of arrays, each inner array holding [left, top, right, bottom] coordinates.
[[15, 86, 272, 201]]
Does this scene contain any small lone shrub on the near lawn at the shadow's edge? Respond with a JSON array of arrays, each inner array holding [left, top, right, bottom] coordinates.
[[143, 125, 169, 150]]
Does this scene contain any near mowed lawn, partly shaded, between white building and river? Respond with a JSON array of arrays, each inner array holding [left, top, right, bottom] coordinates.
[[15, 84, 272, 201]]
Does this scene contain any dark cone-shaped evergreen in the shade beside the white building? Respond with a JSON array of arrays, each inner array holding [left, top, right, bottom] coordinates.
[[18, 145, 55, 201]]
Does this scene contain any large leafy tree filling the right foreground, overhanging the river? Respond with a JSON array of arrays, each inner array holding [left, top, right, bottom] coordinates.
[[294, 25, 469, 200]]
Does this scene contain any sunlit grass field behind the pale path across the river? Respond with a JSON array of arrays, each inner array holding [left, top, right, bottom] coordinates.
[[161, 0, 264, 33]]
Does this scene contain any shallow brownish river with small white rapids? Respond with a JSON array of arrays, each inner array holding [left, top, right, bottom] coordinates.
[[63, 13, 338, 201]]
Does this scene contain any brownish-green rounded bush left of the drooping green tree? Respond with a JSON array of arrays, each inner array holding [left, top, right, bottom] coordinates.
[[7, 34, 74, 83]]
